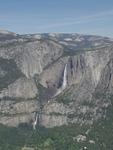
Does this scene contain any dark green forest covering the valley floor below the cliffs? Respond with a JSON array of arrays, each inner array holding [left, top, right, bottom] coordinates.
[[0, 103, 113, 150]]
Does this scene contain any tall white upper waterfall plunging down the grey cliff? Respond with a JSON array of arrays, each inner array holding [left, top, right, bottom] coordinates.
[[55, 64, 67, 96]]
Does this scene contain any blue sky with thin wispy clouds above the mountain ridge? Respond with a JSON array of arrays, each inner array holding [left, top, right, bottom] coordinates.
[[0, 0, 113, 38]]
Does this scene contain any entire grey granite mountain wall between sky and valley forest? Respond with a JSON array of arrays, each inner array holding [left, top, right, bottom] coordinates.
[[0, 31, 113, 127]]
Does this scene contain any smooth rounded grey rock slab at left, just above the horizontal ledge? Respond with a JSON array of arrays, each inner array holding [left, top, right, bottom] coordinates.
[[0, 78, 38, 99]]
